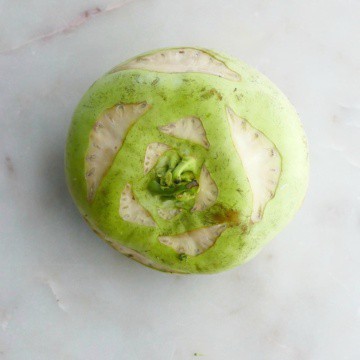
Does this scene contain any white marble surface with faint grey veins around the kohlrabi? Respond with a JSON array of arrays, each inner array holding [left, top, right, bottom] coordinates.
[[0, 0, 360, 360]]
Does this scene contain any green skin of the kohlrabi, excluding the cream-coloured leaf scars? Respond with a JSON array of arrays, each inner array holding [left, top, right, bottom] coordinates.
[[65, 49, 308, 273]]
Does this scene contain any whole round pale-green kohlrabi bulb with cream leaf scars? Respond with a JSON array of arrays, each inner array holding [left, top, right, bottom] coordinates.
[[66, 48, 308, 274]]
